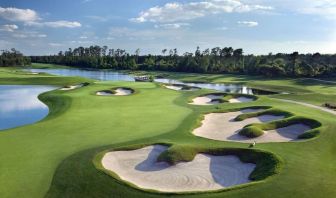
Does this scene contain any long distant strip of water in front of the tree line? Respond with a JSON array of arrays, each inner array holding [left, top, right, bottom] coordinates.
[[28, 69, 276, 95]]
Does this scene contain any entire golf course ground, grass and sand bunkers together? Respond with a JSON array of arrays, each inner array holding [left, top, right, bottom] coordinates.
[[0, 63, 336, 198]]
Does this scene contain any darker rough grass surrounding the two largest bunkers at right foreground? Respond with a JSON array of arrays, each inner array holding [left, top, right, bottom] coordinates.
[[47, 98, 336, 197]]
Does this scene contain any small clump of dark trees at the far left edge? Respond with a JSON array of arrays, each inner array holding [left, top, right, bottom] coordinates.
[[0, 48, 30, 67]]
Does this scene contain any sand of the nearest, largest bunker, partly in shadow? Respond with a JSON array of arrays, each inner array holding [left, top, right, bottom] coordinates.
[[102, 145, 255, 192]]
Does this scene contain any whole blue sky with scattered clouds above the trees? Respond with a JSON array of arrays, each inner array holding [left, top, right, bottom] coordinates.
[[0, 0, 336, 55]]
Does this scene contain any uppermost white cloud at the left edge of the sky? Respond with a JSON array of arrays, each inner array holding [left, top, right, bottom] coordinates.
[[0, 7, 39, 22]]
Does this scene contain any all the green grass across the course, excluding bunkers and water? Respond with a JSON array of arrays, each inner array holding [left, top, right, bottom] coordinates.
[[0, 65, 336, 198]]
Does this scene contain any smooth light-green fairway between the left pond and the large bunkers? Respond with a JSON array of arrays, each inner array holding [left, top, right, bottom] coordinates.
[[0, 77, 191, 197]]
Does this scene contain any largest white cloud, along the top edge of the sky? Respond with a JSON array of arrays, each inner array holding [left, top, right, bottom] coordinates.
[[130, 0, 273, 23]]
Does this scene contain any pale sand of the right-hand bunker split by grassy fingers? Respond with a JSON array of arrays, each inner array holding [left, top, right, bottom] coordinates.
[[193, 109, 311, 143]]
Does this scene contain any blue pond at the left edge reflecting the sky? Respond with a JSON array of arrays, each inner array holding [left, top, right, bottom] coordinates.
[[0, 85, 55, 130]]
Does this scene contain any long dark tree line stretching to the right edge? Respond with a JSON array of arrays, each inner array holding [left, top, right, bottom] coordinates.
[[30, 45, 336, 77]]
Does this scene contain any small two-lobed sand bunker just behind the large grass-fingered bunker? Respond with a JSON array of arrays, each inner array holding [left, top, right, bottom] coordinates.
[[190, 94, 253, 105]]
